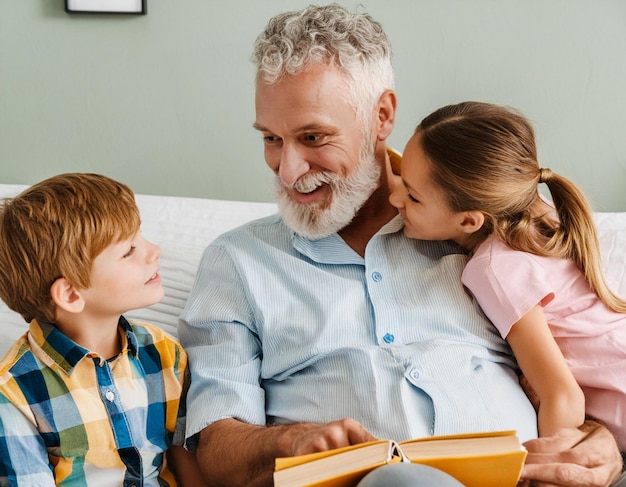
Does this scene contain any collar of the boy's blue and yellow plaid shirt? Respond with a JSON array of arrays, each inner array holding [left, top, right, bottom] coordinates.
[[29, 316, 139, 375]]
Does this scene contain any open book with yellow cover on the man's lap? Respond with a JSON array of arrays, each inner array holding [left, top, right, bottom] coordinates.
[[274, 431, 526, 487]]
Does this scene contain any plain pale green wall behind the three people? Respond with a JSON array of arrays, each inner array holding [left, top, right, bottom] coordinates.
[[0, 0, 626, 211]]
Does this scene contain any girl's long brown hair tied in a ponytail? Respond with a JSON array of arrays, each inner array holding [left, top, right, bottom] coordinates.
[[416, 102, 626, 313]]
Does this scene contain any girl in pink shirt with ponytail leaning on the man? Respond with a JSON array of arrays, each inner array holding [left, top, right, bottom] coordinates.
[[390, 102, 626, 451]]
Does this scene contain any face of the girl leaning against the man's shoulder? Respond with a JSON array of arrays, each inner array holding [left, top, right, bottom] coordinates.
[[389, 133, 466, 244]]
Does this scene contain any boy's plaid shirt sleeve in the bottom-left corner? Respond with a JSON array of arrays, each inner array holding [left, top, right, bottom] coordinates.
[[0, 394, 55, 487]]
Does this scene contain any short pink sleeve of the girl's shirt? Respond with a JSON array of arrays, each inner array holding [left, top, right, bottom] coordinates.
[[461, 247, 554, 338]]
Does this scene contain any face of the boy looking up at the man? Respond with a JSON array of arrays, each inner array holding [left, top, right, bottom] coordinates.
[[82, 232, 163, 317]]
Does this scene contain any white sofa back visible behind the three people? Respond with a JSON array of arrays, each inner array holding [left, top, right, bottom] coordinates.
[[0, 184, 626, 356]]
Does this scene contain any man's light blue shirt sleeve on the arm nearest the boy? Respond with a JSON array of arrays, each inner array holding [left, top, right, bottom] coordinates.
[[178, 243, 265, 449]]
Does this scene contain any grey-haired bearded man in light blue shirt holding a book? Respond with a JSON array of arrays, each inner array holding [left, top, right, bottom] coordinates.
[[179, 5, 621, 486]]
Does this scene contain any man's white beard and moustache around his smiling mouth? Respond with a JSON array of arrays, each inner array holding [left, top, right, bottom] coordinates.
[[275, 143, 381, 240]]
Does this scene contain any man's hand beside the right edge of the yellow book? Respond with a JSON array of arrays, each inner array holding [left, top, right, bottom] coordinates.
[[522, 420, 622, 487]]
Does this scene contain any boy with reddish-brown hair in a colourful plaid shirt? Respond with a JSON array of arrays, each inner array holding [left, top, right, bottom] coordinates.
[[0, 173, 202, 487]]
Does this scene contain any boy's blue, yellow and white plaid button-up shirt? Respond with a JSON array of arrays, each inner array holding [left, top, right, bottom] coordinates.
[[0, 317, 188, 487]]
